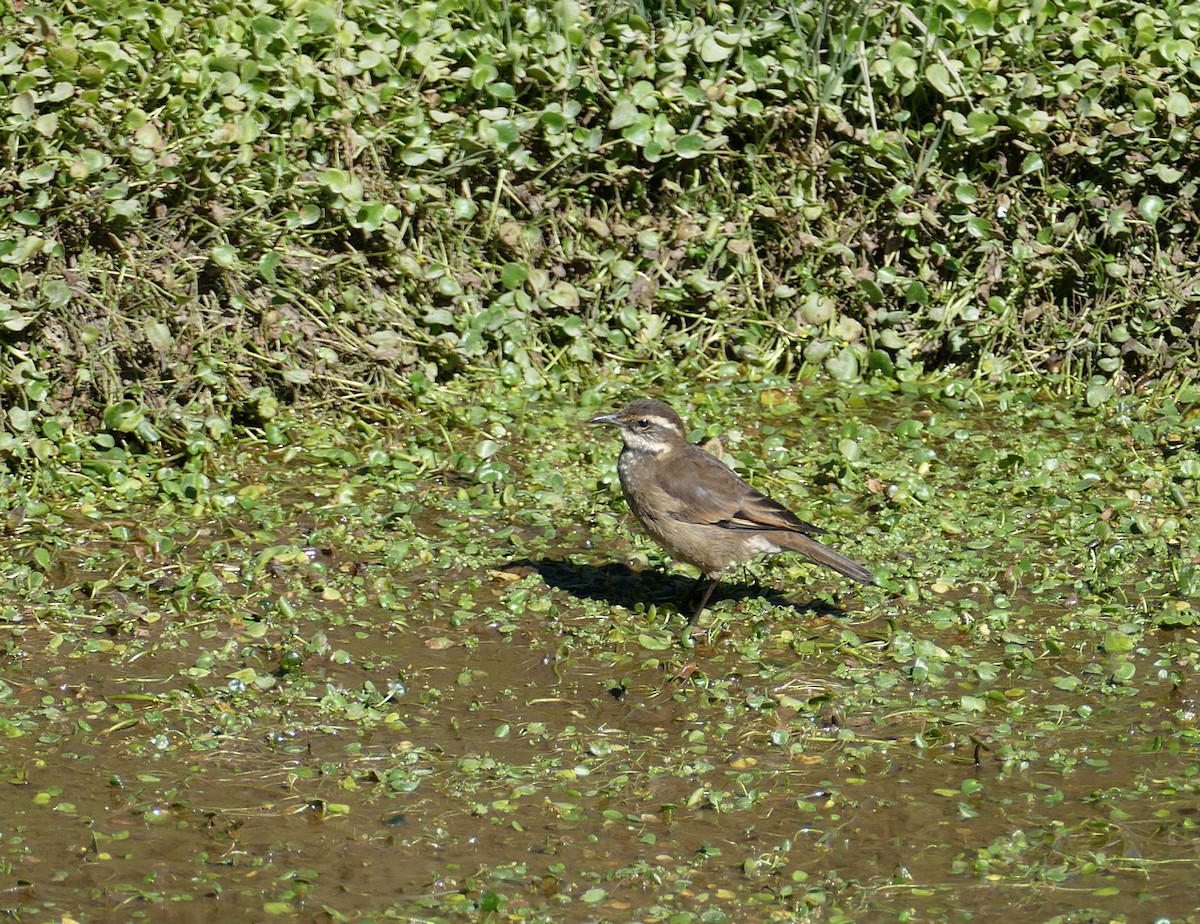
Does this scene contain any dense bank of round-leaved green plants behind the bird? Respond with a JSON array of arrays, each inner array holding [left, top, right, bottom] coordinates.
[[0, 0, 1200, 462]]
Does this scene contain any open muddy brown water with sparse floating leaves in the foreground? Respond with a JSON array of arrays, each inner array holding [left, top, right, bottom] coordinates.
[[0, 578, 1200, 920]]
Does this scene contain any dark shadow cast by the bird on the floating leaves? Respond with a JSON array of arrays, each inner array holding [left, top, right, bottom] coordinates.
[[503, 558, 844, 616]]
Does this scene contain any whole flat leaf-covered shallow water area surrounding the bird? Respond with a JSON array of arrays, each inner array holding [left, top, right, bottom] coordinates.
[[0, 382, 1200, 922]]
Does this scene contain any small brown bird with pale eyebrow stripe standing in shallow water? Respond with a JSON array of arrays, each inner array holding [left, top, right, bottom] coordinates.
[[589, 398, 875, 625]]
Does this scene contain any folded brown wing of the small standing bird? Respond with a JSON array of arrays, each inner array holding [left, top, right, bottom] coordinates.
[[658, 445, 824, 535]]
